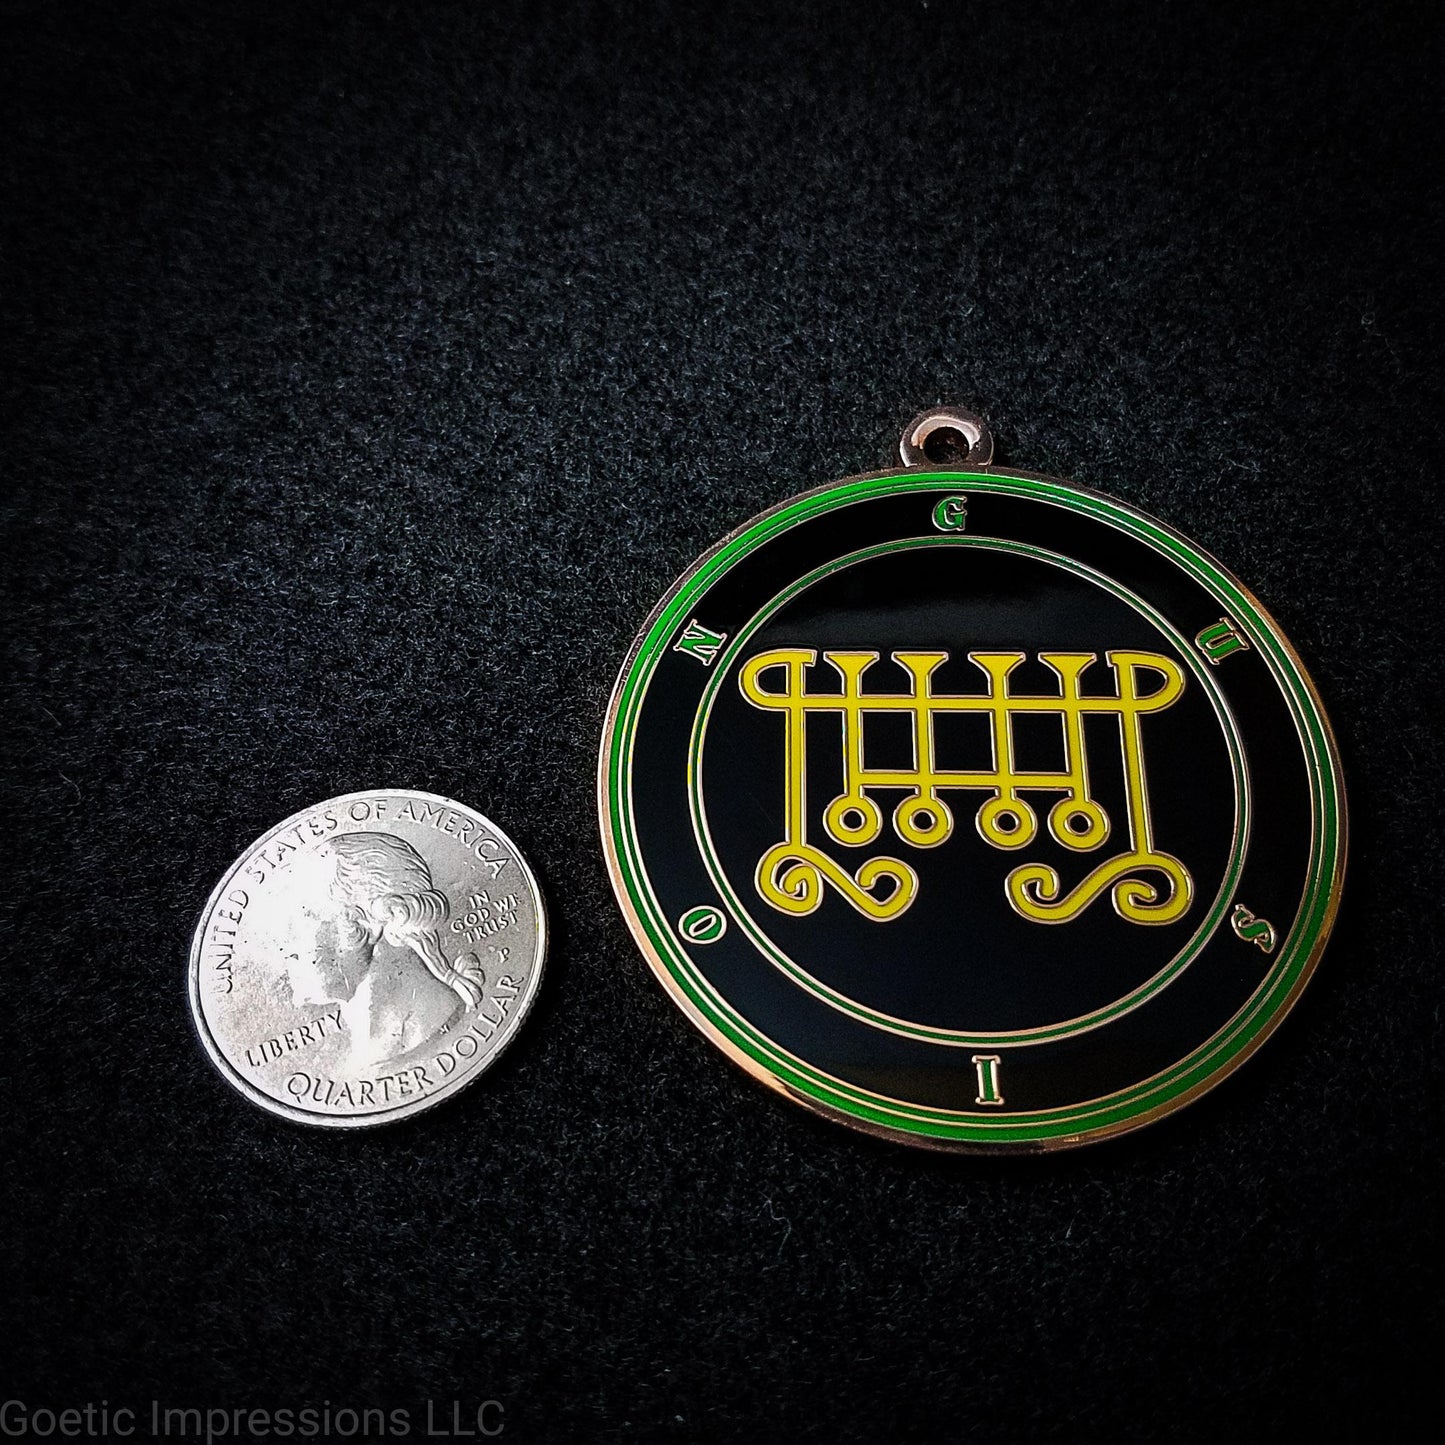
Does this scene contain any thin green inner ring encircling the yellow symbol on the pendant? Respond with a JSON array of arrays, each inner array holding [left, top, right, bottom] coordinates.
[[688, 535, 1250, 1049]]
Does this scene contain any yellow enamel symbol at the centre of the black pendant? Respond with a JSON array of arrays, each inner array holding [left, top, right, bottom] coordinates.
[[738, 647, 1194, 923]]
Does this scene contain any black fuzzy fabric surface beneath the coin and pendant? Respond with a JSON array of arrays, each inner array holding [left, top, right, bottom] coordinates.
[[0, 0, 1445, 1441]]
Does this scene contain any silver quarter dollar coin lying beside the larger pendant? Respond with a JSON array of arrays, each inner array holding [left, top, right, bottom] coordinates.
[[189, 788, 546, 1129]]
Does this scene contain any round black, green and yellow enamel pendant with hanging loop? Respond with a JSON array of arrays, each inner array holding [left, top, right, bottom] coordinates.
[[598, 413, 1345, 1150]]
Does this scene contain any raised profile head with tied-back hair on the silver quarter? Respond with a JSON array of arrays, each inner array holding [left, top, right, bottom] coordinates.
[[277, 832, 484, 1065]]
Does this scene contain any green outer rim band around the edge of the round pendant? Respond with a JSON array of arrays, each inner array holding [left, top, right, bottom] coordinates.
[[598, 471, 1347, 1150]]
